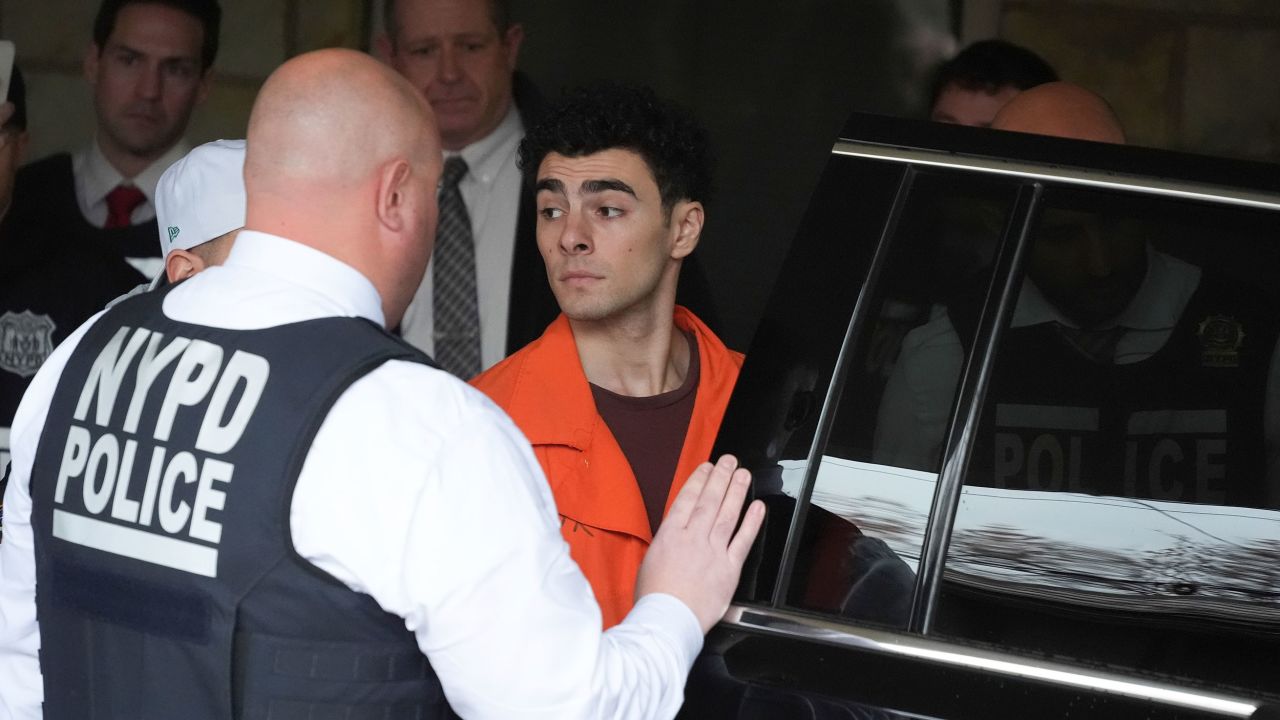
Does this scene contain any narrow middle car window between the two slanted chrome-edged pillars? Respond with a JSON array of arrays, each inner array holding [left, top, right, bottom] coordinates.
[[762, 170, 1018, 628]]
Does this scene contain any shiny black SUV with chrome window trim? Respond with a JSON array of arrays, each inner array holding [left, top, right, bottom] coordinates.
[[682, 115, 1280, 719]]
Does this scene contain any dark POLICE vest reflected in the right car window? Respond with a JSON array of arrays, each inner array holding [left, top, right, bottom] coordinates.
[[968, 278, 1276, 506]]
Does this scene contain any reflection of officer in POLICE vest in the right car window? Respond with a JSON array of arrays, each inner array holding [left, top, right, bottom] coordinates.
[[967, 192, 1277, 507]]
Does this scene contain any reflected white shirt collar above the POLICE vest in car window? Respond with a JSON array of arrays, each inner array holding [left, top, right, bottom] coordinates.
[[1012, 245, 1201, 331]]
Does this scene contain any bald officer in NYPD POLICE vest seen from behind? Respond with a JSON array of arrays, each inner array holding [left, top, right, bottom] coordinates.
[[0, 50, 763, 720]]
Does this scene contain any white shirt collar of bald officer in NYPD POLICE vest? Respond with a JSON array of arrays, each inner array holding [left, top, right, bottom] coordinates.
[[220, 229, 387, 327]]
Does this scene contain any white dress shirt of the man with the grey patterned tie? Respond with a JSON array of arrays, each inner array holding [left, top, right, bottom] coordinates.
[[401, 104, 525, 370]]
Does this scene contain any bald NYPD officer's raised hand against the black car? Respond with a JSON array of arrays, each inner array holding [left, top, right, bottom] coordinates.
[[636, 455, 764, 633]]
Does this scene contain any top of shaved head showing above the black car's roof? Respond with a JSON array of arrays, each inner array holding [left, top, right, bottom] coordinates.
[[991, 82, 1125, 143]]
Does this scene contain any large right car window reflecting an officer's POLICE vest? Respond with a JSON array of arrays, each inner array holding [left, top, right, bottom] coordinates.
[[933, 181, 1280, 692]]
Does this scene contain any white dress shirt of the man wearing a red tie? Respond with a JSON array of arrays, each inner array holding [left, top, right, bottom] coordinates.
[[72, 141, 191, 278]]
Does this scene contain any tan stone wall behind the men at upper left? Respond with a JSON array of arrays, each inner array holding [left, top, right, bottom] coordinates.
[[0, 0, 369, 159]]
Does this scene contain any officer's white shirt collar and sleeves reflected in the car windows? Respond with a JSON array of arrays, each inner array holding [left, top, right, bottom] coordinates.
[[872, 246, 1280, 487]]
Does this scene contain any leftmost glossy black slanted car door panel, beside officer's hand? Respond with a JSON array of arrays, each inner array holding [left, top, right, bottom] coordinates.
[[714, 158, 904, 602]]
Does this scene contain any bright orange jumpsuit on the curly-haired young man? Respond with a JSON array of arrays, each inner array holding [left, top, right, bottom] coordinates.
[[471, 306, 742, 628]]
